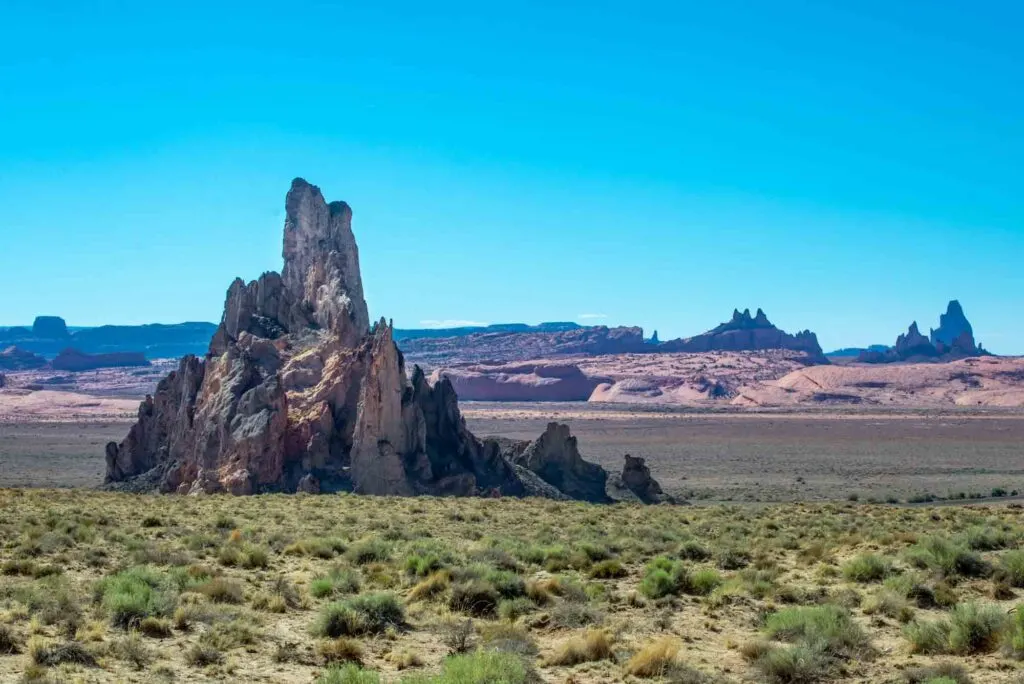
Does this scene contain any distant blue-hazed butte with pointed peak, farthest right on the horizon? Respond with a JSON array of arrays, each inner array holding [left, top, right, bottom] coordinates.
[[858, 300, 989, 364]]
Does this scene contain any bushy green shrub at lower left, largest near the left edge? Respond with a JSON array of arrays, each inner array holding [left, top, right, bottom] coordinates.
[[94, 566, 177, 630]]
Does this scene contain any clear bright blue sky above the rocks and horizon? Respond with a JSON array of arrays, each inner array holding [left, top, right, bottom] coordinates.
[[0, 0, 1024, 353]]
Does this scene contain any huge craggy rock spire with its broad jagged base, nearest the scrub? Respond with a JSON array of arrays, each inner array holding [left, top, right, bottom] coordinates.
[[106, 179, 647, 501]]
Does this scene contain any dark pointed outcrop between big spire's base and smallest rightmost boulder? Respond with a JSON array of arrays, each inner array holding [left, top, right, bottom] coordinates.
[[514, 423, 608, 502]]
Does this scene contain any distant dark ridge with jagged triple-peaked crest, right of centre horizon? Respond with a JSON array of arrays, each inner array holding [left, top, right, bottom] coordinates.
[[656, 309, 828, 364]]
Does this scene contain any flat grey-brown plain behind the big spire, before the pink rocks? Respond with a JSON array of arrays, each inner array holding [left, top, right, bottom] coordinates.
[[0, 402, 1024, 502]]
